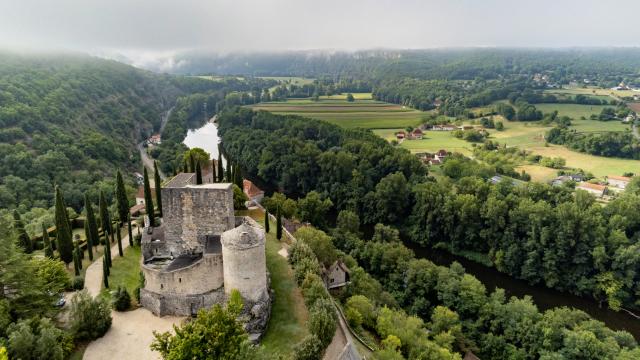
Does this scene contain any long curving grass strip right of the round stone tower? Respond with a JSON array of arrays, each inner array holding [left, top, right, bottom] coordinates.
[[241, 210, 309, 359]]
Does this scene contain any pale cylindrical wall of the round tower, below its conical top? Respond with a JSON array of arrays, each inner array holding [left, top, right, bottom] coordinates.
[[222, 242, 268, 301]]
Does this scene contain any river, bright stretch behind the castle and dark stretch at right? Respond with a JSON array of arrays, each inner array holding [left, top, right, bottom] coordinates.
[[184, 121, 640, 340]]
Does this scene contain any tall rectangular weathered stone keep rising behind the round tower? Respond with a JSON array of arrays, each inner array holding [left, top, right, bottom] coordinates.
[[162, 184, 235, 255]]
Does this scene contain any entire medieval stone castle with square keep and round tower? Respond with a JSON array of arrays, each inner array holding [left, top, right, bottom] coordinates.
[[140, 173, 271, 339]]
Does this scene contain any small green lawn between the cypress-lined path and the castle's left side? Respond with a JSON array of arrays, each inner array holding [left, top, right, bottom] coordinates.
[[100, 246, 142, 303]]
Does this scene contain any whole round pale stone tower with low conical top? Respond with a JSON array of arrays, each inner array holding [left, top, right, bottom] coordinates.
[[220, 220, 269, 302]]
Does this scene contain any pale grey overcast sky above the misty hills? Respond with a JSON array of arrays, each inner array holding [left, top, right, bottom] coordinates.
[[0, 0, 640, 61]]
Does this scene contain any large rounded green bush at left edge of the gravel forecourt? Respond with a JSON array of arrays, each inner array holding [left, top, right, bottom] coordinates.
[[70, 290, 111, 341]]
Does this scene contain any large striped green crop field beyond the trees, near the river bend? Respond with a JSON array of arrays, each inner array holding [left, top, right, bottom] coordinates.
[[251, 93, 424, 129]]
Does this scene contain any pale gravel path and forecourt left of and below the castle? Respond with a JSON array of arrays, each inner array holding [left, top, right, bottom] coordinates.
[[83, 229, 184, 360]]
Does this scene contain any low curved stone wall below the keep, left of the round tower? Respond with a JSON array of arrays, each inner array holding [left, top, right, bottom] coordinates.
[[142, 254, 224, 296]]
